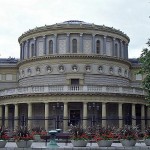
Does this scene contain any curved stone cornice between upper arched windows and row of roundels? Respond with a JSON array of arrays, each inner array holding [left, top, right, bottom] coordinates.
[[17, 54, 131, 67]]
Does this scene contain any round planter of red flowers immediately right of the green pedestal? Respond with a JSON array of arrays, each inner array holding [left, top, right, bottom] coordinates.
[[69, 126, 89, 147]]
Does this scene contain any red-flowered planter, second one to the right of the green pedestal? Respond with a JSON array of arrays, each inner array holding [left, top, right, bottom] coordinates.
[[94, 127, 114, 147]]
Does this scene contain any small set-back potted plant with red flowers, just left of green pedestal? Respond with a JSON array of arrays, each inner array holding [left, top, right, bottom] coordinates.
[[32, 127, 47, 142]]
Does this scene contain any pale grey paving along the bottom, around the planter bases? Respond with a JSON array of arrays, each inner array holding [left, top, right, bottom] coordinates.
[[0, 142, 150, 150]]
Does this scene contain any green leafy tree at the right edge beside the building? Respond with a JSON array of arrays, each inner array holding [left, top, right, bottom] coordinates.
[[138, 39, 150, 106]]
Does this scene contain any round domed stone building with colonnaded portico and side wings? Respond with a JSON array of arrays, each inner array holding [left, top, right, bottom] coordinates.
[[0, 20, 148, 130]]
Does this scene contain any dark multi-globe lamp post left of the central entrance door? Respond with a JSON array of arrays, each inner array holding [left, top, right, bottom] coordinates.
[[53, 102, 64, 129]]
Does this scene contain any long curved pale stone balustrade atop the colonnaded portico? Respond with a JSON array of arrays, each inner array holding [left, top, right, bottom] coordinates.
[[0, 85, 145, 96]]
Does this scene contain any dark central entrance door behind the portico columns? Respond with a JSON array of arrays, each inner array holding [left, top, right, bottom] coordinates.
[[70, 110, 80, 125]]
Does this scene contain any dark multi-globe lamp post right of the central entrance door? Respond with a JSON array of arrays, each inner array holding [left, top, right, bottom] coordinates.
[[88, 102, 99, 126]]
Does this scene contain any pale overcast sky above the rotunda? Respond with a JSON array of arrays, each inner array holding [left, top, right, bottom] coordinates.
[[0, 0, 150, 58]]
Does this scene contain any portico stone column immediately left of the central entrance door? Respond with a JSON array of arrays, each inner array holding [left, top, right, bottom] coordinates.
[[63, 102, 68, 131]]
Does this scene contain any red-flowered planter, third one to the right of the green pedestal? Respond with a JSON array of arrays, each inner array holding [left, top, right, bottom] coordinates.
[[118, 126, 139, 147]]
